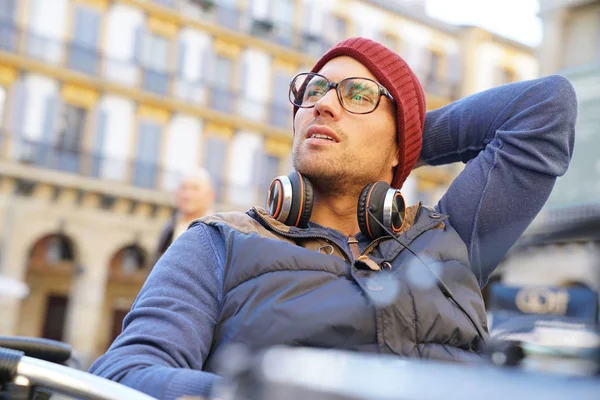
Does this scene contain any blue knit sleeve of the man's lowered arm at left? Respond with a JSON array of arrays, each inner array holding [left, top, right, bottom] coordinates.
[[90, 224, 224, 400]]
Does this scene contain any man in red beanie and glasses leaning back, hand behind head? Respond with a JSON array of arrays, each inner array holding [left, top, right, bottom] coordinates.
[[91, 38, 576, 399]]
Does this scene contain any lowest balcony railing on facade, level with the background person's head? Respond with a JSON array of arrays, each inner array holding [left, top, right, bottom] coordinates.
[[0, 132, 278, 207]]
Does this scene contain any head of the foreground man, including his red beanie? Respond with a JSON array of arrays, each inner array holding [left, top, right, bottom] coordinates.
[[293, 38, 426, 190]]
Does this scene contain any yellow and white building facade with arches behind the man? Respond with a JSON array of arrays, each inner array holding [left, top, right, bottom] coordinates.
[[0, 0, 538, 364]]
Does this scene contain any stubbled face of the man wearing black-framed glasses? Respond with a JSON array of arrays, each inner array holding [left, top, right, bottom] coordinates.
[[293, 56, 398, 190]]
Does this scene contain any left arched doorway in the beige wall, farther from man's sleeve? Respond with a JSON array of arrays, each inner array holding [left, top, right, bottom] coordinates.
[[18, 233, 77, 341]]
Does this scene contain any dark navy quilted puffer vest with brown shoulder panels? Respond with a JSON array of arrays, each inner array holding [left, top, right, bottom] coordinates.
[[201, 205, 487, 371]]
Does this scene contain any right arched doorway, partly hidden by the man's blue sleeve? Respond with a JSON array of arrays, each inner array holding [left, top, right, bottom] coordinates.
[[99, 244, 150, 353]]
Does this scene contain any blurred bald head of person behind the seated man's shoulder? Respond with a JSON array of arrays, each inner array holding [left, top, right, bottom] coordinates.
[[175, 168, 215, 218]]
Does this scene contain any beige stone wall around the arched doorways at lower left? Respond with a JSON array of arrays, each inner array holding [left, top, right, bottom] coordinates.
[[0, 180, 166, 364]]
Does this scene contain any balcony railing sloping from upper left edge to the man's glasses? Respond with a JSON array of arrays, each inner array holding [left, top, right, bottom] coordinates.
[[0, 20, 292, 129]]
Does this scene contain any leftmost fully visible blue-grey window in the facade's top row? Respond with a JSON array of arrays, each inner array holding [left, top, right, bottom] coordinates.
[[68, 4, 101, 75]]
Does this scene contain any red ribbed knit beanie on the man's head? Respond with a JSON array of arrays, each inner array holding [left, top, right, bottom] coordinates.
[[294, 37, 426, 189]]
